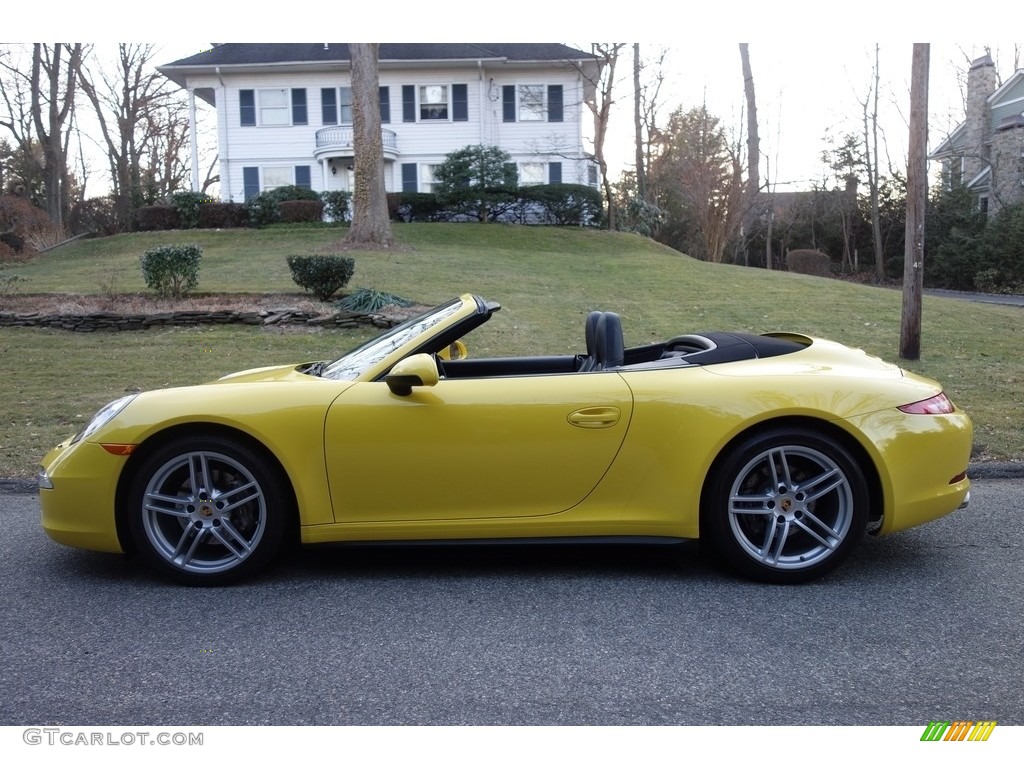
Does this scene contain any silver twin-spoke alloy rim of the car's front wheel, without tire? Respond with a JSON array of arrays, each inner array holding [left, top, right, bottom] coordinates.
[[142, 451, 267, 573]]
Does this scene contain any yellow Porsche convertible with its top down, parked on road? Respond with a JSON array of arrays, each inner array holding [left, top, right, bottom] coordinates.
[[39, 294, 971, 585]]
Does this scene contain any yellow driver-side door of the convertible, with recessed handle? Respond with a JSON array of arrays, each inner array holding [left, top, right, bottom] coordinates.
[[325, 372, 633, 522]]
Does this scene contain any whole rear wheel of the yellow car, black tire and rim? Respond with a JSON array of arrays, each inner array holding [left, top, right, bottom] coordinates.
[[700, 428, 869, 584]]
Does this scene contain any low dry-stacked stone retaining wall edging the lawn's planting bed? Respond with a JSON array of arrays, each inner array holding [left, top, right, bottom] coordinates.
[[0, 307, 400, 332]]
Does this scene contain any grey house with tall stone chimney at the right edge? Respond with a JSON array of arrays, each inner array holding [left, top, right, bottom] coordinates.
[[930, 54, 1024, 213]]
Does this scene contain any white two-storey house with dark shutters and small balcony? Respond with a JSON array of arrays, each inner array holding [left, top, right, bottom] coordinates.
[[160, 43, 598, 202]]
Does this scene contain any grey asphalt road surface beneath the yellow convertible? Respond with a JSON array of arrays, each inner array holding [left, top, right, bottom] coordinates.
[[0, 479, 1024, 727]]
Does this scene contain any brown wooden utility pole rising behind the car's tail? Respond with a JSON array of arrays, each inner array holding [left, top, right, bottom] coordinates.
[[899, 43, 930, 360]]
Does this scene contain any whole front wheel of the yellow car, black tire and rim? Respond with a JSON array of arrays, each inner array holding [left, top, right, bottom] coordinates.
[[126, 435, 292, 587]]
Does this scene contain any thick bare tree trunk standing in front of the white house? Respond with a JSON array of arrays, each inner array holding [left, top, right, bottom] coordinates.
[[345, 43, 394, 248]]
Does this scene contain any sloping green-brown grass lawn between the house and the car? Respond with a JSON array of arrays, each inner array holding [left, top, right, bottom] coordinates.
[[0, 224, 1024, 477]]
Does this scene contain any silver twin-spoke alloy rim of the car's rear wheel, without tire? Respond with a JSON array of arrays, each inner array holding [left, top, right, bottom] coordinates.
[[728, 445, 854, 570]]
